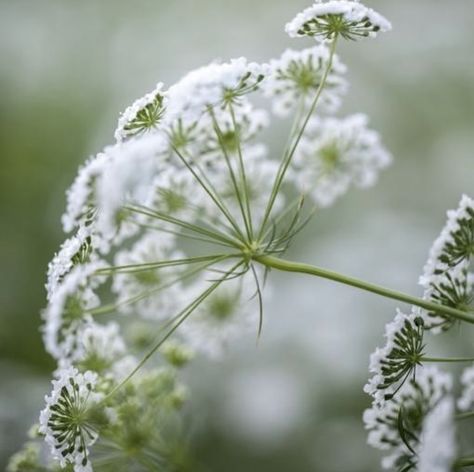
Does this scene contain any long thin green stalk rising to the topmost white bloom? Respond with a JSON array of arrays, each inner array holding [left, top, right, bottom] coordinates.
[[259, 36, 337, 239]]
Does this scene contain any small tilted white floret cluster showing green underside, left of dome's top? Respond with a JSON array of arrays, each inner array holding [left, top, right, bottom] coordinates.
[[114, 82, 166, 142]]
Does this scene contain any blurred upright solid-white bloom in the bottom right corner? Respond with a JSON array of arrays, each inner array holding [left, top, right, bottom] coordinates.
[[417, 397, 457, 472]]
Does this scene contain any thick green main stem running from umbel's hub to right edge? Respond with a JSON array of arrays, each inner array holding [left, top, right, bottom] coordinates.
[[253, 256, 474, 324]]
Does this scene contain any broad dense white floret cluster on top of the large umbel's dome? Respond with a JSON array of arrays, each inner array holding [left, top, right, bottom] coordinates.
[[167, 57, 266, 123]]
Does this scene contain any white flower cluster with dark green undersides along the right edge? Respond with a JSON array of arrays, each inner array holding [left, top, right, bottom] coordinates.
[[364, 195, 474, 472]]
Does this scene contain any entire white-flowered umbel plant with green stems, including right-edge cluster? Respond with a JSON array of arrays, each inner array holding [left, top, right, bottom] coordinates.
[[9, 0, 474, 472]]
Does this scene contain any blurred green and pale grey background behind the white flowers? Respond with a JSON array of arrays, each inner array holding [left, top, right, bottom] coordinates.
[[0, 0, 474, 472]]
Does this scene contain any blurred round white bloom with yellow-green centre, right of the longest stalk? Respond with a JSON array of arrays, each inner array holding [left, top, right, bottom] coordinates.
[[294, 114, 391, 207]]
